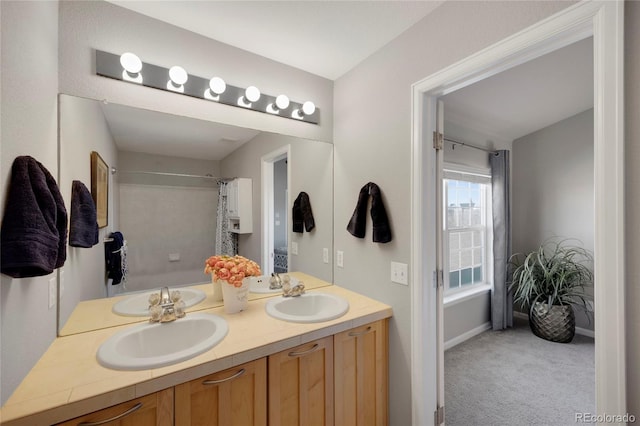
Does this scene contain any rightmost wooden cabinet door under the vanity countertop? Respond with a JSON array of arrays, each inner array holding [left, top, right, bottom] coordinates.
[[333, 320, 388, 426]]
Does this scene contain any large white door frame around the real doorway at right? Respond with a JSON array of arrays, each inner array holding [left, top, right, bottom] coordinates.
[[411, 0, 627, 425]]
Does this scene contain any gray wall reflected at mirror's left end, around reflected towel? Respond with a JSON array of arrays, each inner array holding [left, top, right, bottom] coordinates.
[[58, 95, 118, 328]]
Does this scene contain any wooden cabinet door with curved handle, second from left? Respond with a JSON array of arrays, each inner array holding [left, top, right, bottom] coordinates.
[[175, 358, 267, 426]]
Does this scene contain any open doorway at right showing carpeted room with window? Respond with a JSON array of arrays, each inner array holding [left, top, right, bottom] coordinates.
[[440, 37, 596, 426]]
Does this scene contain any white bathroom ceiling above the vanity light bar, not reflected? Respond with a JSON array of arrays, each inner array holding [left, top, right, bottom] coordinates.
[[108, 0, 443, 80]]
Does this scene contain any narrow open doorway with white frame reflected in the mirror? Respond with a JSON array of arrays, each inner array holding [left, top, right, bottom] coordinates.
[[261, 145, 290, 275]]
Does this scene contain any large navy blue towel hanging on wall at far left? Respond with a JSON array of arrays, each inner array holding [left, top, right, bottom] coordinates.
[[0, 156, 67, 278]]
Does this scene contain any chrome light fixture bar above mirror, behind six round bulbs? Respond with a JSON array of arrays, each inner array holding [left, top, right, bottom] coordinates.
[[96, 50, 320, 124]]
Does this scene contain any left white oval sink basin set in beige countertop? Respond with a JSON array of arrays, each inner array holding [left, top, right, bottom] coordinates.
[[96, 313, 229, 370]]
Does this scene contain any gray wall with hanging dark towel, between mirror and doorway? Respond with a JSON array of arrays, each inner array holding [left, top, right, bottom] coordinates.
[[334, 1, 571, 425]]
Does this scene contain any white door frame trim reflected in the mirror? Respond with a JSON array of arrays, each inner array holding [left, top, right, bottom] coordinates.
[[260, 145, 291, 274]]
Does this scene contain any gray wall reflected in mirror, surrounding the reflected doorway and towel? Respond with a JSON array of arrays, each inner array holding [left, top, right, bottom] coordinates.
[[220, 133, 333, 282]]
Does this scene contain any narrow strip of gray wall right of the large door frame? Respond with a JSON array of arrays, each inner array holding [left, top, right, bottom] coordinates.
[[624, 1, 640, 418]]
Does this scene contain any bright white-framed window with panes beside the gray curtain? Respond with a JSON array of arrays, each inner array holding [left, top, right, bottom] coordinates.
[[443, 169, 492, 294]]
